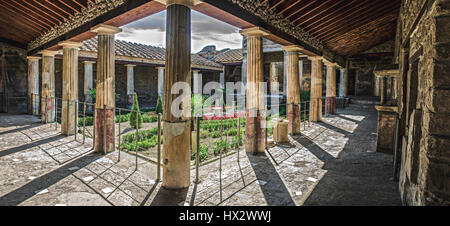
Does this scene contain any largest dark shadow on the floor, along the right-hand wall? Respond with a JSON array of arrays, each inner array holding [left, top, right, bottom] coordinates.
[[299, 112, 401, 206]]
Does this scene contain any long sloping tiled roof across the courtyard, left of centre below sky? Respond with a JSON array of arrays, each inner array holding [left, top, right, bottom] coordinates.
[[80, 38, 223, 68]]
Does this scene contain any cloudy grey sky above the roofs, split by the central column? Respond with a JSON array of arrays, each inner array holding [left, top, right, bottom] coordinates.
[[117, 10, 242, 53]]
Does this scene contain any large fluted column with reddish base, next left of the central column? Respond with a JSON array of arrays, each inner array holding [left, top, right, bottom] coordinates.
[[91, 24, 122, 154]]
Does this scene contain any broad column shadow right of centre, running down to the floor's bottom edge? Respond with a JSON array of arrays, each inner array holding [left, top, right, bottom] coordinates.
[[247, 153, 295, 206]]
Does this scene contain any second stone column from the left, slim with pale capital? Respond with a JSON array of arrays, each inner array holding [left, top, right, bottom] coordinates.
[[40, 50, 58, 123]]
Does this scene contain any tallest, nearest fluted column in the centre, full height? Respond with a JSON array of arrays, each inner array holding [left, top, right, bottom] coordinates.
[[162, 0, 195, 189]]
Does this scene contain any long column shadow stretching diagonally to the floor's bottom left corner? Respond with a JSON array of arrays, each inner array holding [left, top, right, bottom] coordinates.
[[0, 154, 103, 206]]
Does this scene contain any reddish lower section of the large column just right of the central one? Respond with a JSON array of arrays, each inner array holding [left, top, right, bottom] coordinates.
[[245, 110, 265, 154]]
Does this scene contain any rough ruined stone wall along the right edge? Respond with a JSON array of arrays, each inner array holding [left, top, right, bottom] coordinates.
[[396, 0, 450, 205]]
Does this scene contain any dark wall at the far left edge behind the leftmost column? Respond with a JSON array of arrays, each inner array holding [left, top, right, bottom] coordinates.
[[0, 43, 28, 113]]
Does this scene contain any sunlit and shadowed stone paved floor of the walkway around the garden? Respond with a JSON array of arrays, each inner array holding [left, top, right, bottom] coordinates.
[[0, 108, 401, 206]]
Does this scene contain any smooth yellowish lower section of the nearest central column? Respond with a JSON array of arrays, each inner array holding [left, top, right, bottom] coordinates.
[[162, 121, 191, 189]]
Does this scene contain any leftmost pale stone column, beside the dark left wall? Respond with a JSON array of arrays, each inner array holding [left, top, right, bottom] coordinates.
[[27, 56, 41, 115]]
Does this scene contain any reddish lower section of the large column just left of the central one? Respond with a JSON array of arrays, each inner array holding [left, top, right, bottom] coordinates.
[[94, 108, 115, 154]]
